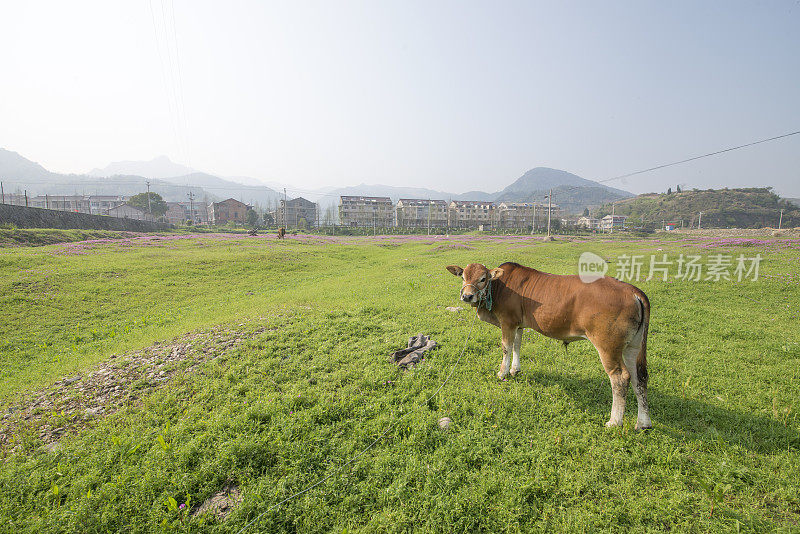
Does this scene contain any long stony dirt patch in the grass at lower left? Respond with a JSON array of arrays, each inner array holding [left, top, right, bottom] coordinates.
[[0, 325, 267, 457]]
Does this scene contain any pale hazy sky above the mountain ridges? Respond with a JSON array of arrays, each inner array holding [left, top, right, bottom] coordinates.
[[0, 0, 800, 197]]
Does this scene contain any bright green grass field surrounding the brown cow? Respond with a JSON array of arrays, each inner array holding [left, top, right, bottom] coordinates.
[[0, 234, 800, 533]]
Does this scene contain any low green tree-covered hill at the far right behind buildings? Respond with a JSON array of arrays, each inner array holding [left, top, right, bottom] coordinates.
[[598, 187, 800, 228]]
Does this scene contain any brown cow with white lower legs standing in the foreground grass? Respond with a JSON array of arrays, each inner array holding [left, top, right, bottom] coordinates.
[[447, 263, 652, 429]]
